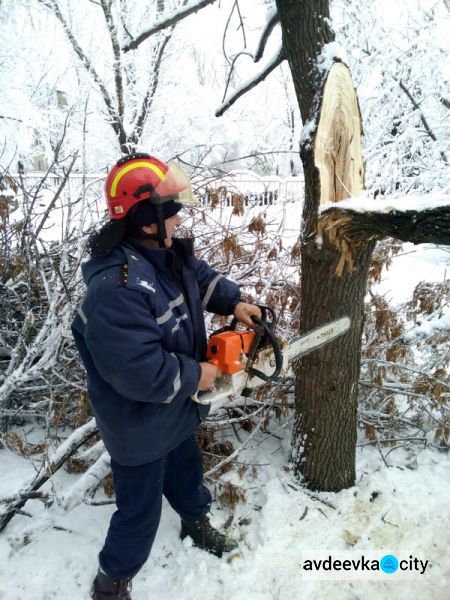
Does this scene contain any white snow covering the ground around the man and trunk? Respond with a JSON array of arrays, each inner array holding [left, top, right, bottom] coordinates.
[[0, 245, 450, 600]]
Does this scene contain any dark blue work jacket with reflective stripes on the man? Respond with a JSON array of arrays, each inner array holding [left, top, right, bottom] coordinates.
[[72, 239, 240, 465]]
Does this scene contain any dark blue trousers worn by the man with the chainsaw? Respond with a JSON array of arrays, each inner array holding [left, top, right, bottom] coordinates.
[[99, 435, 211, 580]]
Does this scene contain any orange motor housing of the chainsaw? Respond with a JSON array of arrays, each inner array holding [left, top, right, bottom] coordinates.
[[207, 331, 255, 375]]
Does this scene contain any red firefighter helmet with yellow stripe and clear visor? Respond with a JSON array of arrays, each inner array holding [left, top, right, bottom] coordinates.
[[105, 153, 196, 220]]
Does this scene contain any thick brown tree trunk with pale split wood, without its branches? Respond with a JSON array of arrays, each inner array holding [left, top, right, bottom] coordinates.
[[277, 0, 375, 491]]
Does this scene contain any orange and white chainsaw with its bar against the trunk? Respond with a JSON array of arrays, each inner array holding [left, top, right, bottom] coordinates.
[[193, 306, 350, 404]]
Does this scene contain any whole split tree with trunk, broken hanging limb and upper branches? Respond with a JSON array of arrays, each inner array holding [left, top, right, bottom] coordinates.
[[124, 0, 449, 490]]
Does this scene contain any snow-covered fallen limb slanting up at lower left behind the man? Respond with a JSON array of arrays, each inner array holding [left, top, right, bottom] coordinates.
[[0, 419, 98, 532]]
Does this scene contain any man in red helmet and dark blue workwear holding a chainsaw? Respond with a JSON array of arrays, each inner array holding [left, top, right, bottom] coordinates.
[[72, 153, 260, 600]]
